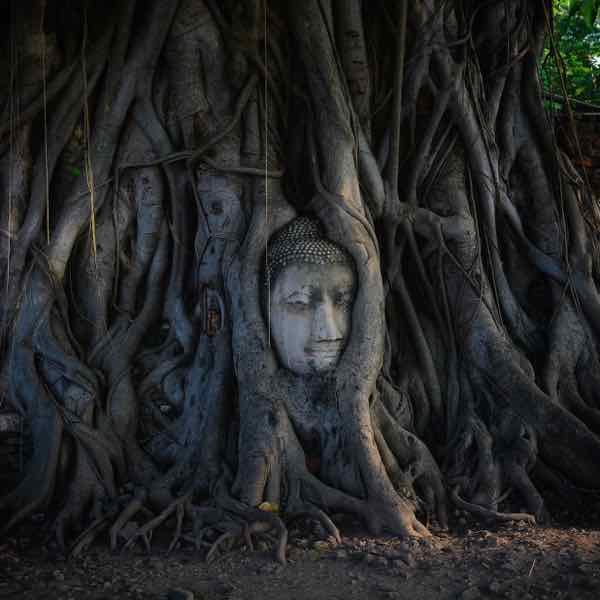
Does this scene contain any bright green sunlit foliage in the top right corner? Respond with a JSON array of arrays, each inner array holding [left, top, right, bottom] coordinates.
[[542, 0, 600, 105]]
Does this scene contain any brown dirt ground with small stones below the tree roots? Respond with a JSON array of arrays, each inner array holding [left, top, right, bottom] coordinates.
[[0, 512, 600, 600]]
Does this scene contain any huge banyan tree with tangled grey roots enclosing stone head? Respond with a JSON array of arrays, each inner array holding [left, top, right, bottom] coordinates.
[[0, 0, 600, 560]]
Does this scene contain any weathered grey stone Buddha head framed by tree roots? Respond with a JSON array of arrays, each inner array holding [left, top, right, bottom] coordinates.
[[266, 216, 356, 375]]
